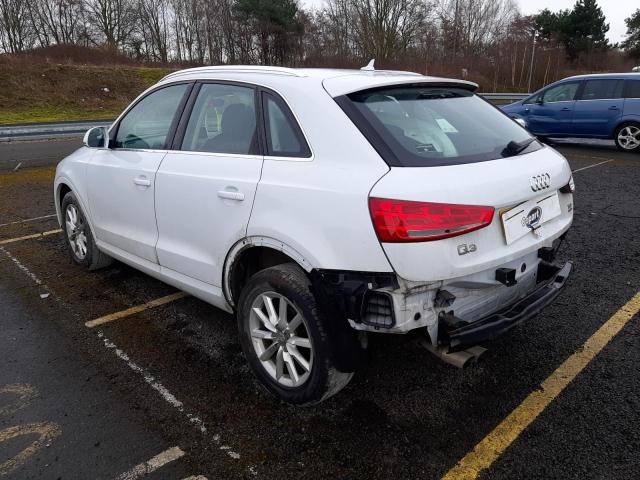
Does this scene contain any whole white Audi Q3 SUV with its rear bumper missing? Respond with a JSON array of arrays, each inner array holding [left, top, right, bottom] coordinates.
[[54, 66, 574, 404]]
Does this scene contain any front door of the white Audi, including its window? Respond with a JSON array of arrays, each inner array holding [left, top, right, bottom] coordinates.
[[87, 83, 190, 263]]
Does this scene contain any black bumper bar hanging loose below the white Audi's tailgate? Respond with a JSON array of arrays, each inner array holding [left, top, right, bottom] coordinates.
[[438, 262, 572, 352]]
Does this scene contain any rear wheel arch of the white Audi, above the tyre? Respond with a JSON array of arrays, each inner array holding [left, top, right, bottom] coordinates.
[[222, 236, 313, 308]]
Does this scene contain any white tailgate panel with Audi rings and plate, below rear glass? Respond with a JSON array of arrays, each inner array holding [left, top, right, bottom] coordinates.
[[370, 147, 573, 281]]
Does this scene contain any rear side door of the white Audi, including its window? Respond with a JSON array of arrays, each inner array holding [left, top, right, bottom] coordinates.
[[156, 82, 263, 286]]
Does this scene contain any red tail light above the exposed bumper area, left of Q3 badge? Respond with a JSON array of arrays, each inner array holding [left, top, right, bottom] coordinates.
[[369, 198, 494, 243]]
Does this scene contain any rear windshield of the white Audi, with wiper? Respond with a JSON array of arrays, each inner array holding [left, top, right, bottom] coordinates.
[[336, 86, 541, 167]]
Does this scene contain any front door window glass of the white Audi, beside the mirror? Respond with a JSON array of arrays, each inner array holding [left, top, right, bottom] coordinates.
[[115, 84, 189, 150]]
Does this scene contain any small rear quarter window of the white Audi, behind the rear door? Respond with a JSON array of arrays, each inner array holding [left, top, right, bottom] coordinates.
[[262, 92, 311, 158]]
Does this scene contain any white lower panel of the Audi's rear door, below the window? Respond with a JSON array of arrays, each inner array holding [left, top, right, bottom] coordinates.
[[156, 152, 262, 287]]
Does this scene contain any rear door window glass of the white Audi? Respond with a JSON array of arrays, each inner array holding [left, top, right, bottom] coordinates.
[[181, 83, 257, 155]]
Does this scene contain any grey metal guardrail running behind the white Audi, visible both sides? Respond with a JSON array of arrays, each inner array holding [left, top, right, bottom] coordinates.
[[0, 93, 531, 142]]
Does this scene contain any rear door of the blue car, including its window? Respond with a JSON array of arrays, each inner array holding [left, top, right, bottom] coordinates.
[[572, 79, 624, 137]]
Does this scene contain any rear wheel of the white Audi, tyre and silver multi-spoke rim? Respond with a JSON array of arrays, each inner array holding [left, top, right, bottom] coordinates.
[[237, 263, 353, 405]]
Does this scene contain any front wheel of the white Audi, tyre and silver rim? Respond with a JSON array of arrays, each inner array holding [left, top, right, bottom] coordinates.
[[62, 192, 113, 270]]
